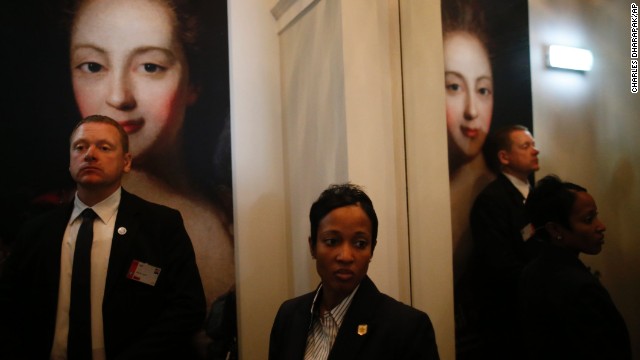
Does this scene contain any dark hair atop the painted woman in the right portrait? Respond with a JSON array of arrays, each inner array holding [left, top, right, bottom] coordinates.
[[441, 0, 491, 54]]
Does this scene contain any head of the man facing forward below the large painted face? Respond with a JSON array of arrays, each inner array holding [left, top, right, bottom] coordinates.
[[69, 122, 131, 191]]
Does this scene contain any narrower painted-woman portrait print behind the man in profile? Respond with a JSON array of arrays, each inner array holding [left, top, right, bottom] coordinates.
[[441, 0, 533, 359]]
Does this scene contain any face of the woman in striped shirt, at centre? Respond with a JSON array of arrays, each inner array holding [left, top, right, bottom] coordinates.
[[311, 205, 373, 299]]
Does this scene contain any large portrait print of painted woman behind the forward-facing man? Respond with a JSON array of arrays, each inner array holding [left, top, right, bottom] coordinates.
[[0, 0, 235, 357]]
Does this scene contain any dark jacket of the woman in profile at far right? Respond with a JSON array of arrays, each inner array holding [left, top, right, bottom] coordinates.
[[520, 245, 631, 360]]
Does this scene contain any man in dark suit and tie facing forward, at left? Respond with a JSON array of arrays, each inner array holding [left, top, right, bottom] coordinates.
[[0, 115, 206, 359]]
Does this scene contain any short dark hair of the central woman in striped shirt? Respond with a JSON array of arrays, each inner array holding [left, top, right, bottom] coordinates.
[[309, 183, 378, 253]]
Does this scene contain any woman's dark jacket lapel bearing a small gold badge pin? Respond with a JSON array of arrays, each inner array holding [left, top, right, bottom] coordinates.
[[329, 276, 380, 360]]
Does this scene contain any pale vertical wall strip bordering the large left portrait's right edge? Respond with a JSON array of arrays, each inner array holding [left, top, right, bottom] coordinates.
[[228, 0, 289, 360]]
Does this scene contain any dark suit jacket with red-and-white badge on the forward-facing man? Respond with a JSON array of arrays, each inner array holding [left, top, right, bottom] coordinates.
[[0, 189, 206, 359]]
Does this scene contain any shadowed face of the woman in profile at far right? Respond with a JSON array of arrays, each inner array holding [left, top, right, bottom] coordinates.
[[559, 191, 607, 255]]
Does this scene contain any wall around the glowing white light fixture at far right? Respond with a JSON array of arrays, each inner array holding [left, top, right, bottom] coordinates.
[[529, 0, 640, 359]]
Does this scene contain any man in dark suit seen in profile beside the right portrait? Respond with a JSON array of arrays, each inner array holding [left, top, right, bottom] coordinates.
[[470, 125, 540, 359]]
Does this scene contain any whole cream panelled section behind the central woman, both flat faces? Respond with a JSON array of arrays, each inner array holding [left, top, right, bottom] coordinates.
[[280, 0, 410, 302]]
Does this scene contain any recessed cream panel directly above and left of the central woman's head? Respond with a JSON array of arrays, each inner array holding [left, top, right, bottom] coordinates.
[[280, 1, 349, 300]]
